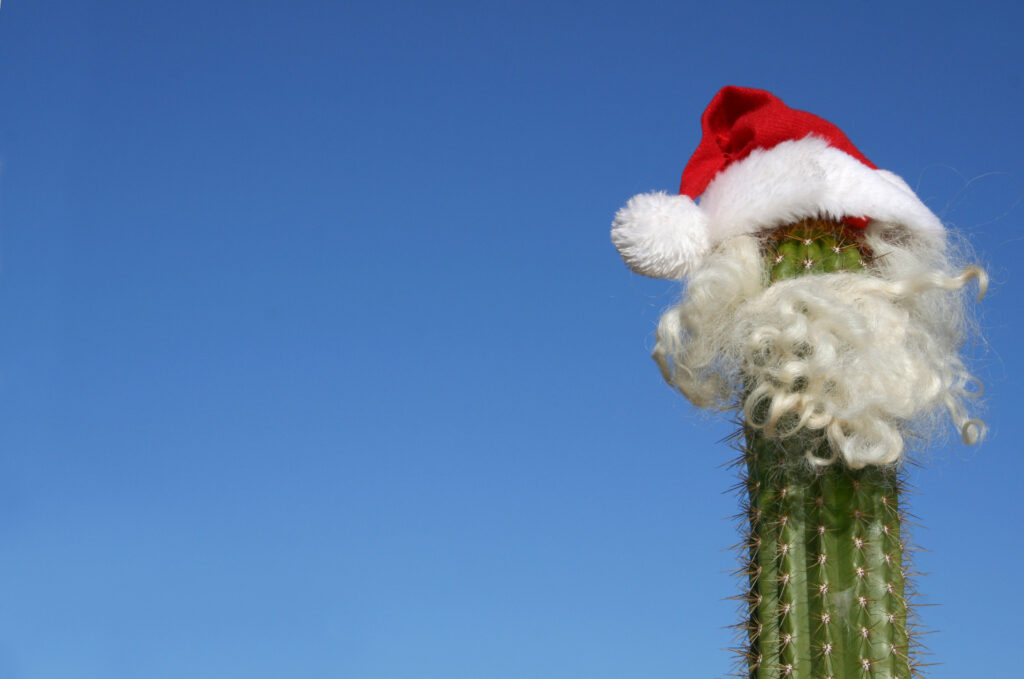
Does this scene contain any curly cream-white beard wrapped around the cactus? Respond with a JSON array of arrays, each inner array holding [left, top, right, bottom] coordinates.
[[653, 222, 987, 468]]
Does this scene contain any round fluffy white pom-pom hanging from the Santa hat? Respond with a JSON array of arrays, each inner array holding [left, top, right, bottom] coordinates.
[[611, 192, 711, 279]]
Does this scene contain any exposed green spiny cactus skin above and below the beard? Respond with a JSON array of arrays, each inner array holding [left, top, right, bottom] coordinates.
[[739, 219, 918, 679]]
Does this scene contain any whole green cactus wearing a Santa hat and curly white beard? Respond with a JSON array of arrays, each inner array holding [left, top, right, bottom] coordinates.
[[611, 87, 986, 679]]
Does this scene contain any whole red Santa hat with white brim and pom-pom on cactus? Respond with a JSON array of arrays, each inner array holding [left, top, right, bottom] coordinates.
[[611, 86, 945, 279]]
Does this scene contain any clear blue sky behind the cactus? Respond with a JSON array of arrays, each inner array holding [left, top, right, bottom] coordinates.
[[0, 0, 1024, 679]]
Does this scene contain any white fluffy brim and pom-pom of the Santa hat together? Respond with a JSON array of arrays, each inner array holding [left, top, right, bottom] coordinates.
[[611, 136, 945, 279]]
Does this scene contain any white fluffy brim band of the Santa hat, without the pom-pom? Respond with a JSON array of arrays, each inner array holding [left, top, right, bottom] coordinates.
[[700, 136, 945, 244]]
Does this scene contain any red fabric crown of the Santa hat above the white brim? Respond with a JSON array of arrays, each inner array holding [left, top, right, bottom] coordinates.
[[679, 85, 878, 199]]
